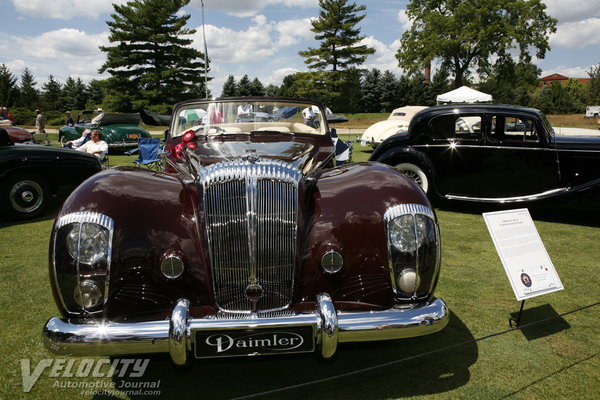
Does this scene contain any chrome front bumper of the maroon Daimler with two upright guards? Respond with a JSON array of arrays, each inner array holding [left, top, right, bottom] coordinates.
[[42, 294, 449, 365]]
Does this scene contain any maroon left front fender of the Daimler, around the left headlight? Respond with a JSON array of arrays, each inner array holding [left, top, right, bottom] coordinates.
[[50, 168, 213, 319]]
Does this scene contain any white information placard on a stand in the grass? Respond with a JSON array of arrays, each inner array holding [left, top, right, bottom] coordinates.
[[483, 208, 563, 301]]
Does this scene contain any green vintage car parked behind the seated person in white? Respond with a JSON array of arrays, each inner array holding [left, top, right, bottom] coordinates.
[[58, 110, 150, 149]]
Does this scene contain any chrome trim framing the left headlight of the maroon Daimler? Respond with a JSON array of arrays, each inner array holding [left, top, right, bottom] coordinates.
[[52, 211, 115, 312]]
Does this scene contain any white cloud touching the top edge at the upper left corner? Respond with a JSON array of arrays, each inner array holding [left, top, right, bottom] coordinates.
[[12, 0, 127, 19]]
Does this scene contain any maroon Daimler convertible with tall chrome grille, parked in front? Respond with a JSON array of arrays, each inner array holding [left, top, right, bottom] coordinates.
[[43, 98, 448, 365]]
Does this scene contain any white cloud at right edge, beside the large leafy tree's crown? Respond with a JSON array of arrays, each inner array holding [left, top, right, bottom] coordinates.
[[550, 18, 600, 49]]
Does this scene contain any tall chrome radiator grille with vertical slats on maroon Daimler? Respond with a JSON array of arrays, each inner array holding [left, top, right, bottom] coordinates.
[[199, 160, 301, 312]]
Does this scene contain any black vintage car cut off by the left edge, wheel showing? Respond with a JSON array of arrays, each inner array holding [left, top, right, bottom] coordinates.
[[0, 128, 101, 219]]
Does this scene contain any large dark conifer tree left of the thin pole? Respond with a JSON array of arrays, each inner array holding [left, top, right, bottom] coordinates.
[[99, 0, 204, 109]]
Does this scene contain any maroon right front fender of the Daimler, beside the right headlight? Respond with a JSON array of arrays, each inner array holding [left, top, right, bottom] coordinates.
[[301, 163, 431, 309]]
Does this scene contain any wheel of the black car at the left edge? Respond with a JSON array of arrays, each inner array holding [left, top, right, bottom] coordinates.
[[2, 175, 49, 219]]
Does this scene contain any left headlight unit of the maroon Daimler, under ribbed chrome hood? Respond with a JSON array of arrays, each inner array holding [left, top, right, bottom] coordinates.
[[53, 212, 114, 313]]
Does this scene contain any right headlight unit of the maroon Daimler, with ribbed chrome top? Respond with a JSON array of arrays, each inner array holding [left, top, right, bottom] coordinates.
[[384, 204, 441, 301]]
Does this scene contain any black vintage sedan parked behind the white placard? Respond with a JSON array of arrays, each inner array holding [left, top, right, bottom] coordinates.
[[370, 104, 600, 204]]
